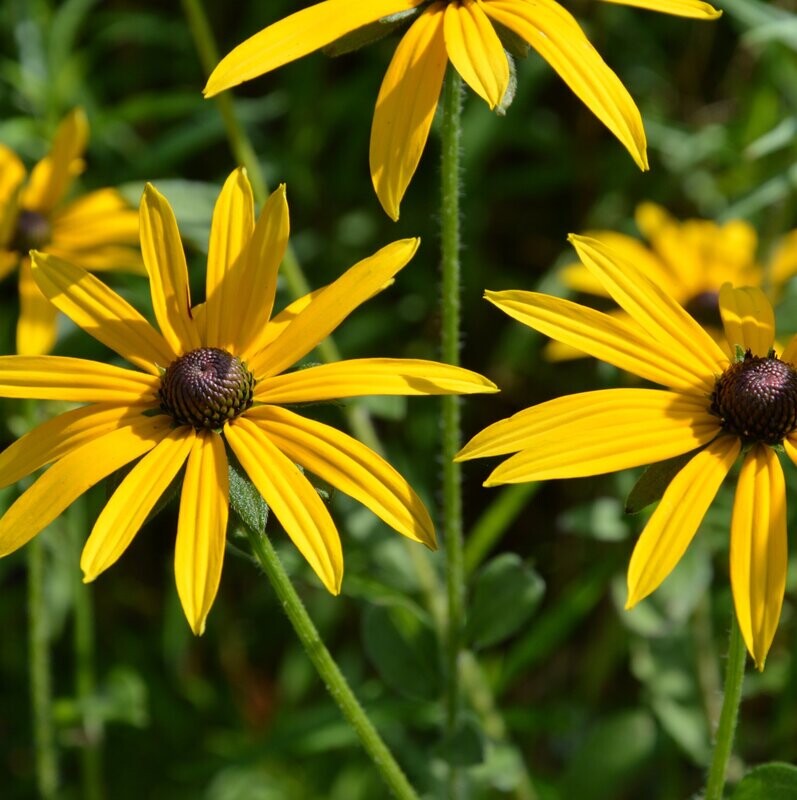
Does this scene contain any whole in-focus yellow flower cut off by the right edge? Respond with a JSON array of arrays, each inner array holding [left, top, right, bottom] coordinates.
[[457, 236, 797, 669]]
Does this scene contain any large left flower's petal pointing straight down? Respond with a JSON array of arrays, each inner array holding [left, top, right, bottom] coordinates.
[[174, 431, 229, 636]]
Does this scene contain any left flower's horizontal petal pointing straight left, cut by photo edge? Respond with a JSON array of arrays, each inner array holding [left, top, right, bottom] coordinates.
[[0, 356, 160, 405]]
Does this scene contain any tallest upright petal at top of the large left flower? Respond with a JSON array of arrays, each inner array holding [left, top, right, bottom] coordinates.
[[205, 167, 255, 350]]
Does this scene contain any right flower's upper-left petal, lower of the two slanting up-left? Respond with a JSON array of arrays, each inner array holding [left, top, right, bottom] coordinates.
[[485, 291, 714, 393]]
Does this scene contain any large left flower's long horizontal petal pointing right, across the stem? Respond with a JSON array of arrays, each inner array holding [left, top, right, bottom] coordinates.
[[255, 358, 498, 403]]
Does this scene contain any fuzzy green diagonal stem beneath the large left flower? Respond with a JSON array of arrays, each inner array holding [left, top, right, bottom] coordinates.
[[246, 529, 418, 800]]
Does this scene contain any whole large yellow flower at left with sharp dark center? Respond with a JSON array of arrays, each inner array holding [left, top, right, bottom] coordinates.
[[0, 169, 496, 634]]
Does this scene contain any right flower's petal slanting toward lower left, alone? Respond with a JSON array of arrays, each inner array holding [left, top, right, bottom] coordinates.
[[626, 436, 741, 608]]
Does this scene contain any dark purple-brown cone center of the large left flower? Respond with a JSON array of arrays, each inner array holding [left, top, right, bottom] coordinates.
[[158, 347, 255, 430]]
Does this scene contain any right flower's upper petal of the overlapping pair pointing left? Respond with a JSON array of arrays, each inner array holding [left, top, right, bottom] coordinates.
[[456, 389, 719, 461]]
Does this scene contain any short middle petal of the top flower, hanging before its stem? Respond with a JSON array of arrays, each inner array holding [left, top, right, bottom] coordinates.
[[444, 0, 509, 109]]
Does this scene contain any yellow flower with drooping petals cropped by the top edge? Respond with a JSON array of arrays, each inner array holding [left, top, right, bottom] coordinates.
[[205, 0, 720, 219]]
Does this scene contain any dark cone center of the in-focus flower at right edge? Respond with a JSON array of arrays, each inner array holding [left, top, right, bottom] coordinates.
[[711, 350, 797, 444]]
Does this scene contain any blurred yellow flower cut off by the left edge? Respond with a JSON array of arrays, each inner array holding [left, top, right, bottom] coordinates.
[[0, 109, 143, 355]]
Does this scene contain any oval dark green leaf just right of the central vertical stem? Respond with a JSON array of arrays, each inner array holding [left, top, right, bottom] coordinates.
[[465, 553, 545, 647]]
